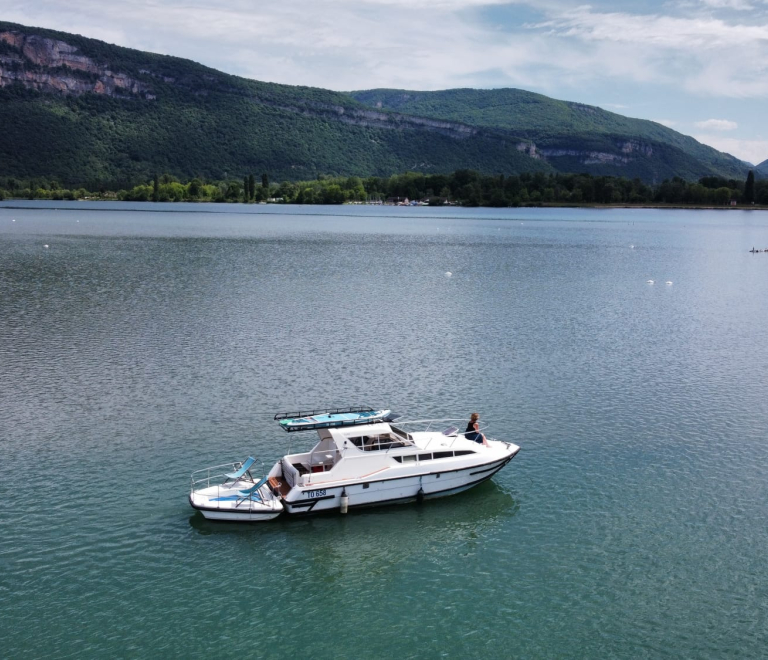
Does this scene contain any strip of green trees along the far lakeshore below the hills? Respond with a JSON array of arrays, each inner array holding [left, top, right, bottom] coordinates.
[[0, 170, 768, 208]]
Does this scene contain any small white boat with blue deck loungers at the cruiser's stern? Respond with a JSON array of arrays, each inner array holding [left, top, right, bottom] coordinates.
[[189, 457, 283, 522]]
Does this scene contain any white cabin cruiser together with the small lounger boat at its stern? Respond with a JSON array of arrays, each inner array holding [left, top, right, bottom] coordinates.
[[189, 408, 520, 521]]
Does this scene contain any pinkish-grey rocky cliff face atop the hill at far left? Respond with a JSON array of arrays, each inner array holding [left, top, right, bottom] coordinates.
[[0, 30, 154, 100]]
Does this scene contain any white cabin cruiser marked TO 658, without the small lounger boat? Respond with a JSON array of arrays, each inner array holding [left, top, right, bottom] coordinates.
[[268, 409, 520, 514]]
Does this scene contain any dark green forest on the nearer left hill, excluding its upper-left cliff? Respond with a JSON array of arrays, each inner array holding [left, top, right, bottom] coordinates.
[[0, 23, 550, 189]]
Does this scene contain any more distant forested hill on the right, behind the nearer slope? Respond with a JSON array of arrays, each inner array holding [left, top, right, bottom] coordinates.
[[350, 89, 749, 181]]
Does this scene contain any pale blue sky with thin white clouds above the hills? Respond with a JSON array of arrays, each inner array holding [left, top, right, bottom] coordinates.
[[6, 0, 768, 164]]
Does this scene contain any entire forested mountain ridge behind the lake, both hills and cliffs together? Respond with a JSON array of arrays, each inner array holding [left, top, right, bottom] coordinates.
[[0, 22, 747, 188]]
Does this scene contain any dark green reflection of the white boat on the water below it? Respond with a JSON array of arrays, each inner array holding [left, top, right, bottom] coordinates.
[[189, 481, 520, 581]]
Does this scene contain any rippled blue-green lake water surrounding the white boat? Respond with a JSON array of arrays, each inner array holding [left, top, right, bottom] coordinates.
[[0, 202, 768, 659]]
